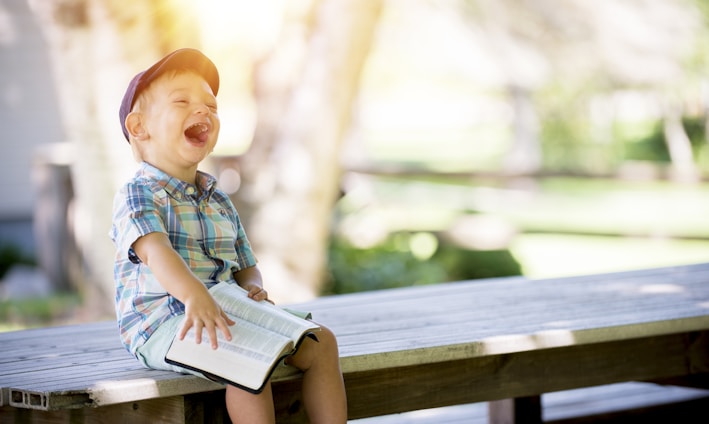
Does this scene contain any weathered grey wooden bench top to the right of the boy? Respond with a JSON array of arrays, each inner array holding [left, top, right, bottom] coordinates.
[[301, 266, 709, 371]]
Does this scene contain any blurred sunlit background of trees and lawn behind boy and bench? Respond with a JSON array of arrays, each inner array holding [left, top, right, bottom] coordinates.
[[0, 0, 709, 330]]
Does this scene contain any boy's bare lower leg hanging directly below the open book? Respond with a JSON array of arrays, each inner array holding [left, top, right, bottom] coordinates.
[[226, 383, 276, 424]]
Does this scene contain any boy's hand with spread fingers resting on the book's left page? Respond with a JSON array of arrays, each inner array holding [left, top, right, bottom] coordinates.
[[179, 291, 235, 349]]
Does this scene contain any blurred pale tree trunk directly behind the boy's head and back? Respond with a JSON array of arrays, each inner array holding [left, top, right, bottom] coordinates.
[[31, 0, 196, 319]]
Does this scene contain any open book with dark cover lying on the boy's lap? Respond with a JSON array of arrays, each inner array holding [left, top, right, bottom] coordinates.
[[165, 282, 320, 393]]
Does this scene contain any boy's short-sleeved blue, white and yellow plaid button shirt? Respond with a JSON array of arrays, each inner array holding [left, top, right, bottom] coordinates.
[[110, 162, 256, 354]]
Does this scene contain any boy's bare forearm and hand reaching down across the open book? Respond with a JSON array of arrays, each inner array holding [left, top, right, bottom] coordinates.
[[133, 232, 234, 349]]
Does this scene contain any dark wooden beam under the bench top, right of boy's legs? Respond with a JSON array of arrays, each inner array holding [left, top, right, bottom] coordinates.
[[316, 334, 709, 419]]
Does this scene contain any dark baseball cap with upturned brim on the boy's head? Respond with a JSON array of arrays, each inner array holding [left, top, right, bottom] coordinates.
[[119, 48, 219, 141]]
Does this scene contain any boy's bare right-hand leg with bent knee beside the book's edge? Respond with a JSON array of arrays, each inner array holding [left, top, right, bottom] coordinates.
[[286, 327, 347, 424]]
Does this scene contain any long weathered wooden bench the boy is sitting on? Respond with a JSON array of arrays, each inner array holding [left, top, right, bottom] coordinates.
[[0, 264, 709, 423]]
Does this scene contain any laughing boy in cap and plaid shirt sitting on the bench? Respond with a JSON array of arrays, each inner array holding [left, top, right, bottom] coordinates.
[[111, 49, 347, 424]]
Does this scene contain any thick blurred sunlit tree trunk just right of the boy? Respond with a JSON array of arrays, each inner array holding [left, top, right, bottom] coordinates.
[[234, 0, 382, 302]]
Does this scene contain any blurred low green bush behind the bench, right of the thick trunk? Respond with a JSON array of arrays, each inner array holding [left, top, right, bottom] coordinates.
[[325, 236, 521, 294]]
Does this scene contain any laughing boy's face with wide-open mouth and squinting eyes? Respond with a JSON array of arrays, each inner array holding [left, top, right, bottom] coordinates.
[[130, 72, 220, 181]]
